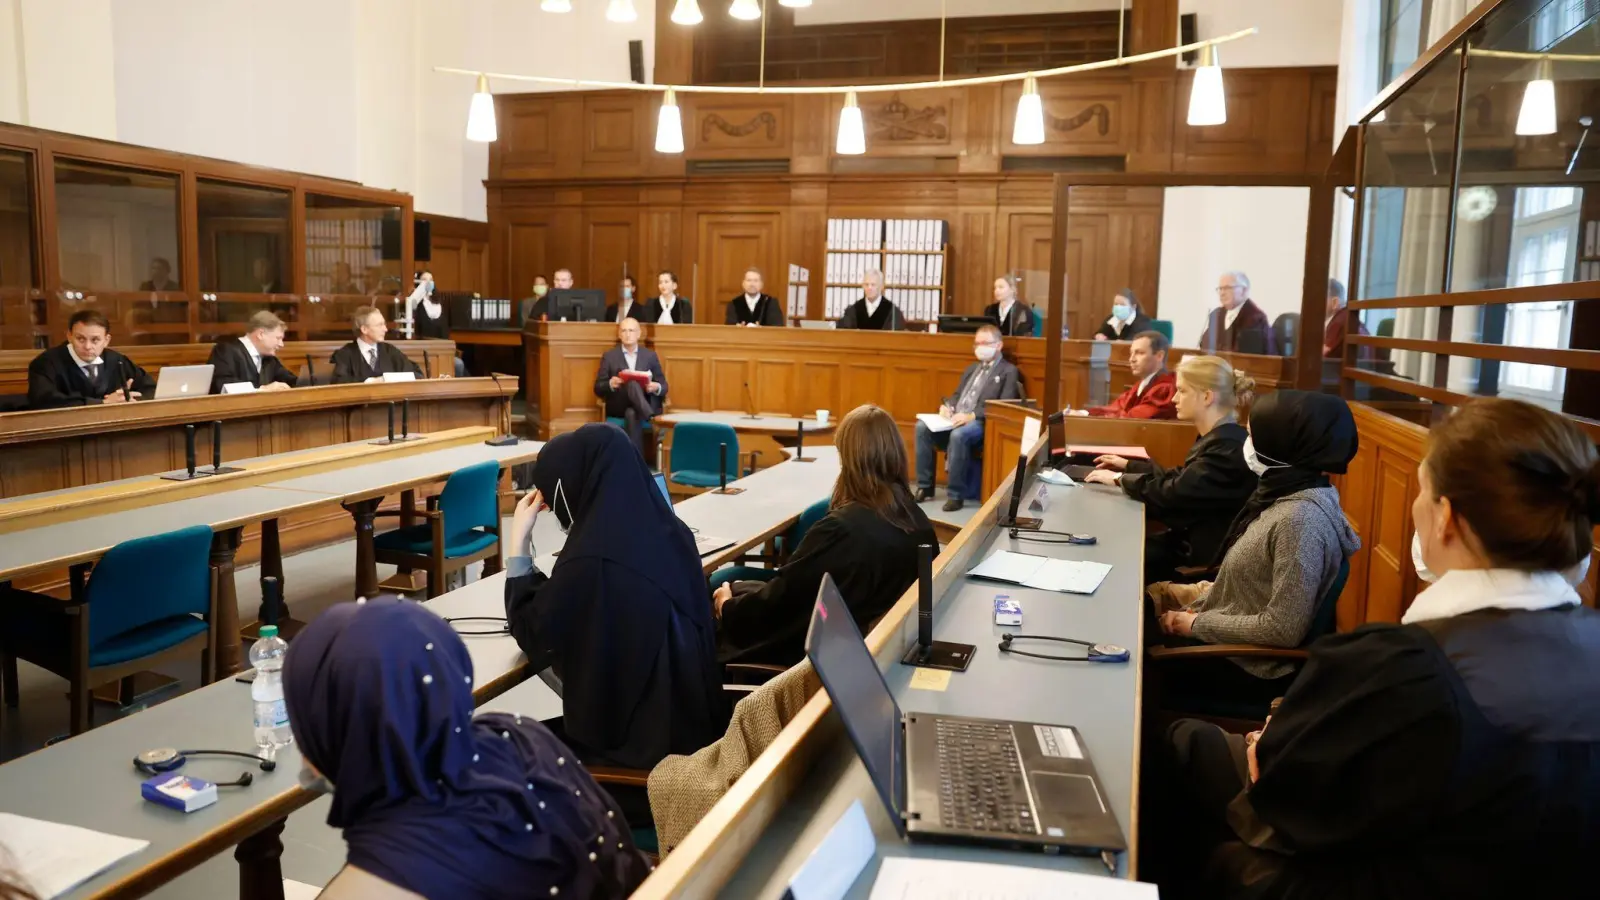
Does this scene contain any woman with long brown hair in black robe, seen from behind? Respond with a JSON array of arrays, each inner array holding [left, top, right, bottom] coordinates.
[[712, 405, 938, 666]]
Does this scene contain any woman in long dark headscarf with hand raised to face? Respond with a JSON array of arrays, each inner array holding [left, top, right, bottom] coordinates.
[[506, 424, 730, 769]]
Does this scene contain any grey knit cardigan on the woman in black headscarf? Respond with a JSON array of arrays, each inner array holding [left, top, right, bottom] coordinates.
[[1189, 487, 1362, 679]]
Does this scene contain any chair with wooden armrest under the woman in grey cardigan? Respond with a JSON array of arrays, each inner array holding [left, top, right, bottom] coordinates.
[[1149, 559, 1350, 720]]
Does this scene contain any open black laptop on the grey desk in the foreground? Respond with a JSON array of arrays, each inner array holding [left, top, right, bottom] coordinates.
[[805, 575, 1128, 865]]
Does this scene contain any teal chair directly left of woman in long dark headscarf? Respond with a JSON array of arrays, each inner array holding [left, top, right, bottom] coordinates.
[[373, 461, 501, 597]]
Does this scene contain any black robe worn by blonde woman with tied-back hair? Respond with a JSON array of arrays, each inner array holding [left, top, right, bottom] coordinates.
[[1122, 421, 1258, 581]]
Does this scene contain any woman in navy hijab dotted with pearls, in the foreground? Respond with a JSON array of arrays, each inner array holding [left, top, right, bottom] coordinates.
[[283, 599, 650, 900]]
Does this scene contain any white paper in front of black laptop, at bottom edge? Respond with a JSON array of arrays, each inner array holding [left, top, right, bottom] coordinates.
[[870, 857, 1160, 900]]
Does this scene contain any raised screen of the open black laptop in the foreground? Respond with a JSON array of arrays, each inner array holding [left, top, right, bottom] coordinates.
[[805, 575, 906, 834]]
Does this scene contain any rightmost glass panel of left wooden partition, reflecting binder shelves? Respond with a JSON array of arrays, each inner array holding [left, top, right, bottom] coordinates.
[[306, 194, 402, 296]]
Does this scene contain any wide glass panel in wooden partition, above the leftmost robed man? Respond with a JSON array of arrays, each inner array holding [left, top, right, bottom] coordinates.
[[54, 159, 182, 291]]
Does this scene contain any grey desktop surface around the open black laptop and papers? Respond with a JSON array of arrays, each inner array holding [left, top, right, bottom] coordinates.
[[723, 485, 1144, 898]]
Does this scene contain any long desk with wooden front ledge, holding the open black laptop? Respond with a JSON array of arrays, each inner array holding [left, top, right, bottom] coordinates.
[[635, 442, 1144, 898]]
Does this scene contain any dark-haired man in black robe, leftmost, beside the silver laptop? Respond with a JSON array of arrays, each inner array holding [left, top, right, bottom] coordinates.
[[27, 309, 155, 410]]
